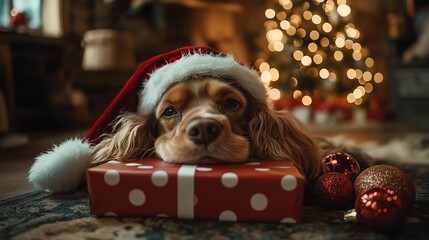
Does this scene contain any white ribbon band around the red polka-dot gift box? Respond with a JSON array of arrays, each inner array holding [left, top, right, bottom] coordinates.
[[177, 165, 197, 219]]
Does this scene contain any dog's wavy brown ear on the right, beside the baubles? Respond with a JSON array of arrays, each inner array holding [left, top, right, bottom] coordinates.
[[249, 107, 322, 183]]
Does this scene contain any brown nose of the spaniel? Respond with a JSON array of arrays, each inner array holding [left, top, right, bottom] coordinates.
[[186, 119, 222, 145]]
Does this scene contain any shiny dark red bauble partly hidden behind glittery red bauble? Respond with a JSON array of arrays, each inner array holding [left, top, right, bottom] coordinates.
[[322, 152, 360, 182]]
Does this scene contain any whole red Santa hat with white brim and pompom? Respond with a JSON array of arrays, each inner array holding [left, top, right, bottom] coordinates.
[[28, 47, 267, 192]]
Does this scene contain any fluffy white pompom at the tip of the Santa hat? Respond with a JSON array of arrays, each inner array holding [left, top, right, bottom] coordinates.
[[28, 138, 91, 192]]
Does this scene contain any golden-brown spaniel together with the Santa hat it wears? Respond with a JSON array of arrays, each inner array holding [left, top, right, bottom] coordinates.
[[29, 47, 322, 192]]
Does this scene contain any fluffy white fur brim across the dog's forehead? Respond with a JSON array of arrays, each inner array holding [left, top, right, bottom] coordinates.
[[137, 52, 267, 115]]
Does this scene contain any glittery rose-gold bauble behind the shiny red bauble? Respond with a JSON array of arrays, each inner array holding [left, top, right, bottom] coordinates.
[[354, 165, 416, 208]]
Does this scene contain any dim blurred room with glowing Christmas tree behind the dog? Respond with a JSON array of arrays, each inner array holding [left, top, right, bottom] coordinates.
[[0, 0, 429, 196]]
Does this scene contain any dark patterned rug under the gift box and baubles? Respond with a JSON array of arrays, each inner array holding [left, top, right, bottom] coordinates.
[[0, 159, 429, 239]]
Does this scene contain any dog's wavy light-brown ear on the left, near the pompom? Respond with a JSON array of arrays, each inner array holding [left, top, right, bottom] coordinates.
[[91, 113, 155, 165]]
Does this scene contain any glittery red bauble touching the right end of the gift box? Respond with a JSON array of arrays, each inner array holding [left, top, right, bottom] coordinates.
[[313, 172, 354, 209]]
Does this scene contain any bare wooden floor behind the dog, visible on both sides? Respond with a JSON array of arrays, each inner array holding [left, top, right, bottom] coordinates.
[[0, 123, 429, 199]]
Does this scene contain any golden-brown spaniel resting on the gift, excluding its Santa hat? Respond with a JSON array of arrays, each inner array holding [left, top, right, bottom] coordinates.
[[92, 76, 322, 181]]
